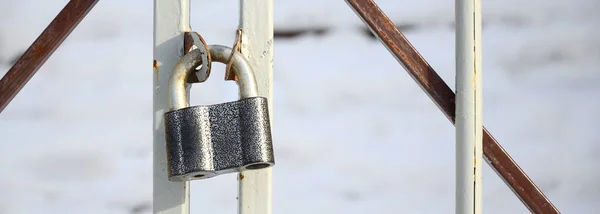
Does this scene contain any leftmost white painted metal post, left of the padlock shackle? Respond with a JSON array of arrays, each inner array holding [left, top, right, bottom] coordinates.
[[152, 0, 190, 214]]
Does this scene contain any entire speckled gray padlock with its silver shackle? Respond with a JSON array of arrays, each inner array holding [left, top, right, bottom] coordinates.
[[164, 45, 275, 181]]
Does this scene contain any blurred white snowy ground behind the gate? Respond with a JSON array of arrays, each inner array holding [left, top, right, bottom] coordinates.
[[0, 0, 600, 214]]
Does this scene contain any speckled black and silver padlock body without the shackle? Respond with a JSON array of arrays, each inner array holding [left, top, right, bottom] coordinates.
[[165, 97, 274, 181]]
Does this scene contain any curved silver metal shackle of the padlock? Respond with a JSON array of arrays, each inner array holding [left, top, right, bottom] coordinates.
[[169, 45, 258, 110]]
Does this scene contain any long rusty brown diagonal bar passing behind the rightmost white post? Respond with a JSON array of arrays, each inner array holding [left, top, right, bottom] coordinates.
[[346, 0, 560, 214]]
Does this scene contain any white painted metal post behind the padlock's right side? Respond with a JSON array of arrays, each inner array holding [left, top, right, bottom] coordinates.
[[238, 0, 275, 214]]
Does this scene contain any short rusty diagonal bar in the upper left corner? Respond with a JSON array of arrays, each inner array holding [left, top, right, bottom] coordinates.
[[0, 0, 98, 113]]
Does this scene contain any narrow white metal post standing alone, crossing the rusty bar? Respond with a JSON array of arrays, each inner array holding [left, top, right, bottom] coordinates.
[[455, 0, 483, 214]]
